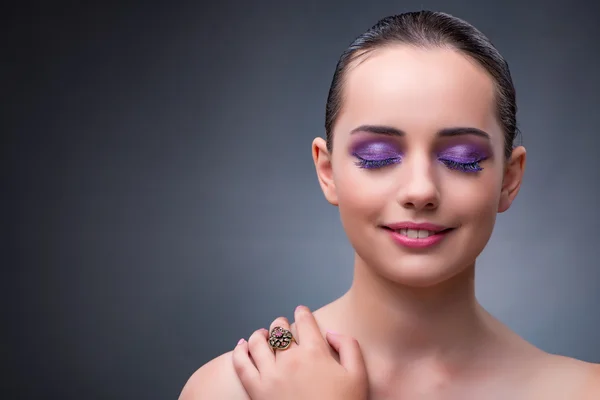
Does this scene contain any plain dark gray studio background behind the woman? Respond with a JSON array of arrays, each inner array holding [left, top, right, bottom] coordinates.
[[0, 0, 600, 399]]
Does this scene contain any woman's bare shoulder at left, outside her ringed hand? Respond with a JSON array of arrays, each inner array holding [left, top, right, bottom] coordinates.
[[179, 352, 250, 400]]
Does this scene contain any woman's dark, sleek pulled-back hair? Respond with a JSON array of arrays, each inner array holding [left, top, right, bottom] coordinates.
[[325, 11, 518, 158]]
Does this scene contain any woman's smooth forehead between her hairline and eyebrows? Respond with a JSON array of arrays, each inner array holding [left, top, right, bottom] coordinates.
[[336, 45, 502, 141]]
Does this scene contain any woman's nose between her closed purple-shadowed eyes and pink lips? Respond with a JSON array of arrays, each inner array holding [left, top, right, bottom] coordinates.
[[397, 156, 440, 211]]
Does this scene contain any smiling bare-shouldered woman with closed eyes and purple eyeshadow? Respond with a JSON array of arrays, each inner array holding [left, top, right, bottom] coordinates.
[[181, 11, 600, 400]]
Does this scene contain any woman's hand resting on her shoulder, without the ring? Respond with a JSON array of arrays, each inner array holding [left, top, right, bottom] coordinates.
[[233, 306, 367, 400]]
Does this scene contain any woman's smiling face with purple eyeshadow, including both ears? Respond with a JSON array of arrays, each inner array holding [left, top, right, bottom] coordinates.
[[313, 46, 524, 286]]
